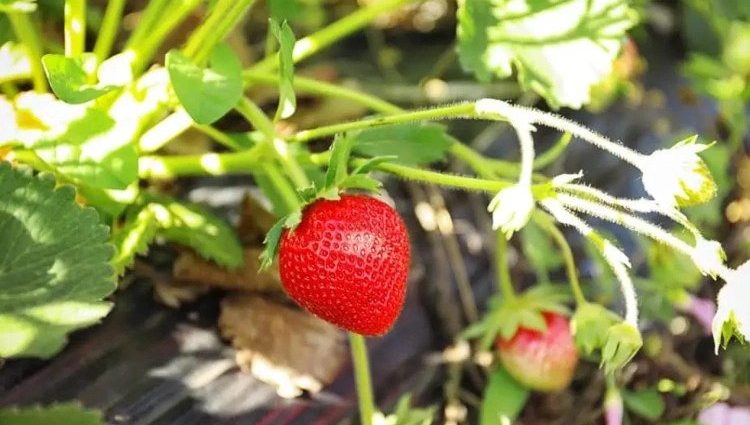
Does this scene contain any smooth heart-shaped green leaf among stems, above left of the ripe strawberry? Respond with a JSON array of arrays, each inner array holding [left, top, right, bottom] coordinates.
[[166, 44, 242, 124]]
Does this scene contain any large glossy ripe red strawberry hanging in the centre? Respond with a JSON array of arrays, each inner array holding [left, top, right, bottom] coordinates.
[[279, 195, 409, 335]]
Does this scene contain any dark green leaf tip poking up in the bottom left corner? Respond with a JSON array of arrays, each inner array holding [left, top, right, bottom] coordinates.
[[0, 403, 104, 425]]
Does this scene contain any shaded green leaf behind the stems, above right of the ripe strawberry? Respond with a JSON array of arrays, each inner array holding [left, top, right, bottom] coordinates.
[[348, 123, 455, 165]]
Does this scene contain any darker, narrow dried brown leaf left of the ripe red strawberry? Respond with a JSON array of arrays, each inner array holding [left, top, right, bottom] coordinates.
[[172, 247, 282, 292]]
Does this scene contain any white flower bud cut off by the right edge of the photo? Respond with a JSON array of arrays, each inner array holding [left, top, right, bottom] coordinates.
[[712, 261, 750, 352]]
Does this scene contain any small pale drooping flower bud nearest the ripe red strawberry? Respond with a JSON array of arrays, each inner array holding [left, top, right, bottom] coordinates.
[[487, 183, 534, 239]]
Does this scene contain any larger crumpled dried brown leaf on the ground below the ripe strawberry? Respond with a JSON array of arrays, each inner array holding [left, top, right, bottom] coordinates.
[[219, 293, 346, 398]]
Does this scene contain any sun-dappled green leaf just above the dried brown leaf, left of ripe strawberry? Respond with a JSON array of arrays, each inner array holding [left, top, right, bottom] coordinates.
[[151, 197, 244, 268]]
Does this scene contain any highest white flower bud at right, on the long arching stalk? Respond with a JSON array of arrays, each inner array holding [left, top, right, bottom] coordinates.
[[637, 136, 716, 208]]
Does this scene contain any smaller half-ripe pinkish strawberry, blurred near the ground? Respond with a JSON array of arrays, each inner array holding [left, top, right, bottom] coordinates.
[[497, 312, 578, 391]]
